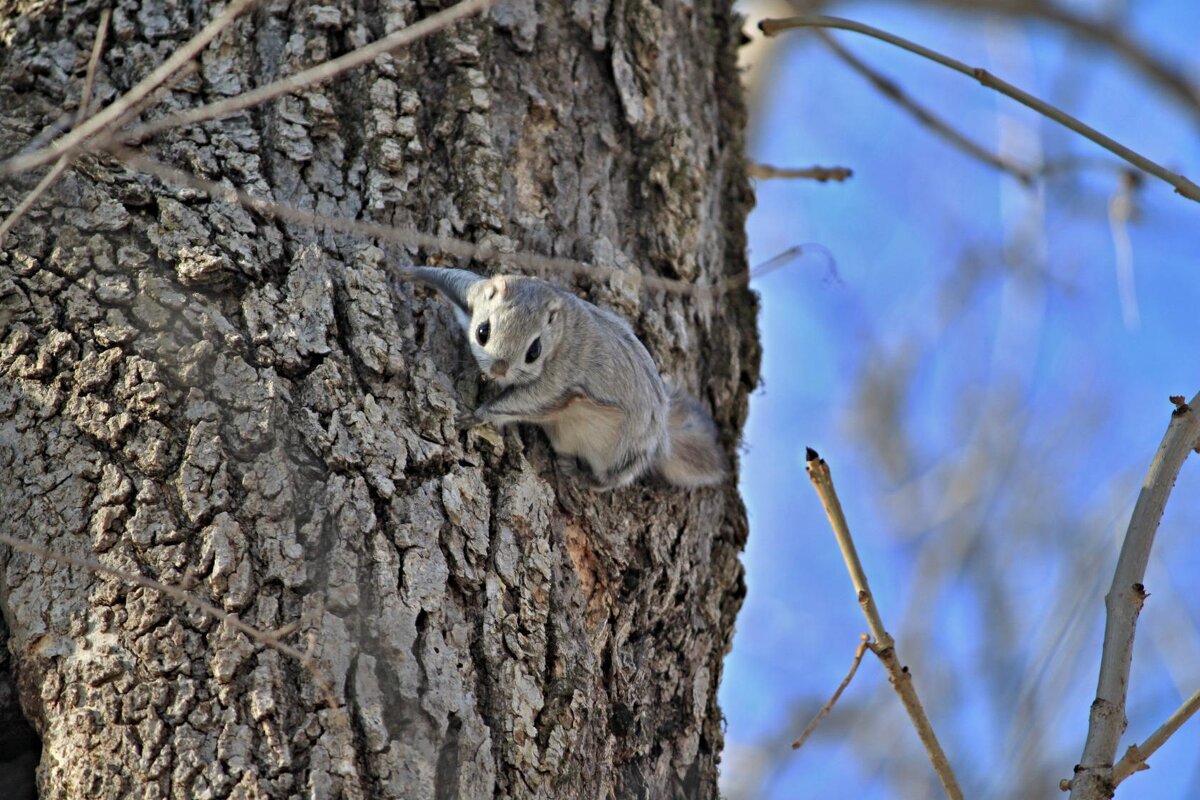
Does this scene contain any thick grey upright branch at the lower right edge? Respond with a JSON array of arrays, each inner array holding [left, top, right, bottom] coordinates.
[[1061, 393, 1200, 800]]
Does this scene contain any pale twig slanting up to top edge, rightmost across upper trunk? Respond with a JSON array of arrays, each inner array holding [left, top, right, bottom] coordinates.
[[114, 0, 496, 144]]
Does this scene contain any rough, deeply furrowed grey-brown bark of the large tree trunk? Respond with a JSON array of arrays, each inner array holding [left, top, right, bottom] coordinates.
[[0, 0, 758, 800]]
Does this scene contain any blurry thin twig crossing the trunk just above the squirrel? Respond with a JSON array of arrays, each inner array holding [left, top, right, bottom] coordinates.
[[108, 144, 758, 295]]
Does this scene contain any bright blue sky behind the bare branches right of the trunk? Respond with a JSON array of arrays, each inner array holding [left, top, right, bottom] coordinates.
[[721, 0, 1200, 800]]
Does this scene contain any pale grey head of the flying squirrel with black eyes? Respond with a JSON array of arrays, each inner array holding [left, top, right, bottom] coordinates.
[[467, 275, 563, 386]]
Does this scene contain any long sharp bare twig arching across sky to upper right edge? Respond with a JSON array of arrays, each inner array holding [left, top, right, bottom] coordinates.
[[758, 16, 1200, 203]]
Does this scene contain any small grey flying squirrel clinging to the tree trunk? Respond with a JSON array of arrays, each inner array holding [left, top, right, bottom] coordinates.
[[402, 266, 726, 491]]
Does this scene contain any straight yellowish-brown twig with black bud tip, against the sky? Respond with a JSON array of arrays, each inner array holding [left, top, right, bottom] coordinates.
[[808, 447, 962, 800]]
